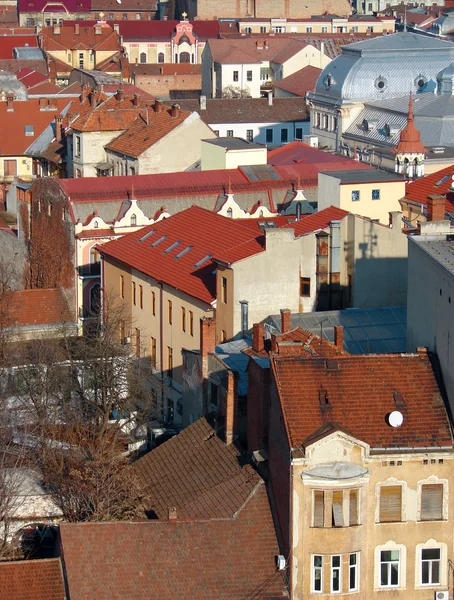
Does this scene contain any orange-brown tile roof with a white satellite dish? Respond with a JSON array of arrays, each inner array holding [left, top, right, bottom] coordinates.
[[271, 354, 454, 449]]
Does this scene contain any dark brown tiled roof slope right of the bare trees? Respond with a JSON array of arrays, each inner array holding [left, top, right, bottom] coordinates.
[[133, 418, 260, 519]]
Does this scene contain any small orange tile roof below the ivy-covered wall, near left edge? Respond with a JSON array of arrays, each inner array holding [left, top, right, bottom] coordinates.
[[10, 289, 72, 327]]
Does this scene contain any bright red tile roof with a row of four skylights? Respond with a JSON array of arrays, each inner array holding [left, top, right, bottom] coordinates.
[[98, 206, 265, 304]]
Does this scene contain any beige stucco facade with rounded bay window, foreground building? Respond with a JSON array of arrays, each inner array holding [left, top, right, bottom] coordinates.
[[290, 431, 454, 600]]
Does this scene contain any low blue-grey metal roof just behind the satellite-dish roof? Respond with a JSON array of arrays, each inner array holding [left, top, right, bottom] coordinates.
[[265, 308, 406, 354]]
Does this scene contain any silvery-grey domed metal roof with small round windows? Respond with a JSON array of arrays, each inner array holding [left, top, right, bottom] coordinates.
[[309, 31, 454, 105]]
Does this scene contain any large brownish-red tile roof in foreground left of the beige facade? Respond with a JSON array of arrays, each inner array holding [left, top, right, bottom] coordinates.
[[60, 482, 287, 600]]
